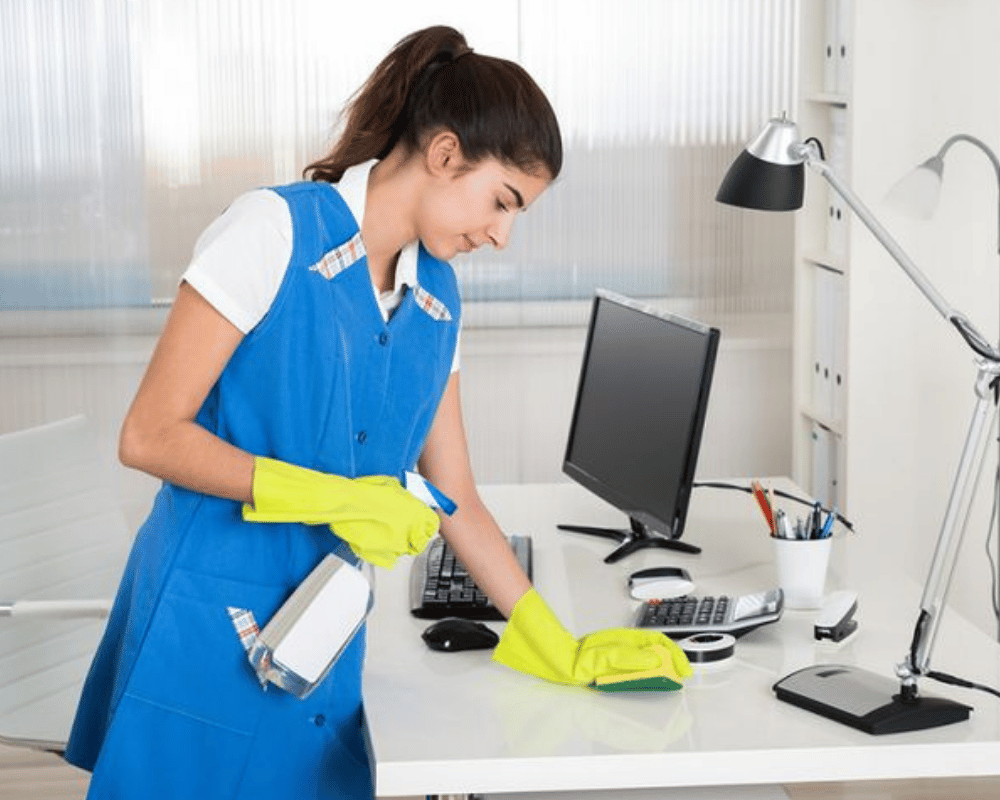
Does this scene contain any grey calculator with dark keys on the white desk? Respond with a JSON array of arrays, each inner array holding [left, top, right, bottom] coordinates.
[[635, 589, 785, 638]]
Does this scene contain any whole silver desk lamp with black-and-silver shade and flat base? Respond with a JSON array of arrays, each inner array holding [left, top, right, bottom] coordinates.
[[716, 117, 1000, 733]]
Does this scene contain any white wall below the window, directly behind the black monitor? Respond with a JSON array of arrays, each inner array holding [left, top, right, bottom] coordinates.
[[462, 315, 791, 483]]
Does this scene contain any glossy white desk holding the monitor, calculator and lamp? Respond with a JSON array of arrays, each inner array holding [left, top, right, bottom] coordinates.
[[365, 481, 1000, 797]]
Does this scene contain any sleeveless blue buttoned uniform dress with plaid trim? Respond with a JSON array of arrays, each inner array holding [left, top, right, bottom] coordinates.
[[66, 183, 459, 800]]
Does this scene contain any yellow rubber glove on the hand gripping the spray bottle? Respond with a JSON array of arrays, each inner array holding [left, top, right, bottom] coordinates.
[[243, 457, 440, 569]]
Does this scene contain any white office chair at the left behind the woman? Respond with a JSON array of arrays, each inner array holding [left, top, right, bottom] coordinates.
[[0, 417, 131, 753]]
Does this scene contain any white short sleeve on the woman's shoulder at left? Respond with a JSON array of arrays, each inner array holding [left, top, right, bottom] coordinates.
[[181, 189, 292, 334]]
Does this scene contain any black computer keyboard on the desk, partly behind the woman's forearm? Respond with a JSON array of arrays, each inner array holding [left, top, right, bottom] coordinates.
[[410, 536, 531, 620]]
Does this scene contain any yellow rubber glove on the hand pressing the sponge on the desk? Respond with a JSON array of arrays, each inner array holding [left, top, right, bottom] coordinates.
[[493, 589, 692, 686]]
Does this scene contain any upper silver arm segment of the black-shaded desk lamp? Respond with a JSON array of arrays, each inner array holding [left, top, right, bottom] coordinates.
[[797, 144, 1000, 362]]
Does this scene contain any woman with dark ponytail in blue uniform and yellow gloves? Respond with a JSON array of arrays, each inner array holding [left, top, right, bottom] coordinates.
[[60, 27, 689, 800]]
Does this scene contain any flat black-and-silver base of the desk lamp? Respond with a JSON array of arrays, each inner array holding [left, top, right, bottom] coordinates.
[[772, 664, 972, 735]]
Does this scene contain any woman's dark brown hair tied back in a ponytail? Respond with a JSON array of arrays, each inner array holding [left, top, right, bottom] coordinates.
[[303, 26, 562, 183]]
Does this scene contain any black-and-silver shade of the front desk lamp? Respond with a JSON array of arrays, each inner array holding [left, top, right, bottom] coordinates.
[[715, 118, 805, 211]]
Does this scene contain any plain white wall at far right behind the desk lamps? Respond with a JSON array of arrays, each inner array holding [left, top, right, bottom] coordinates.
[[848, 0, 1000, 633]]
